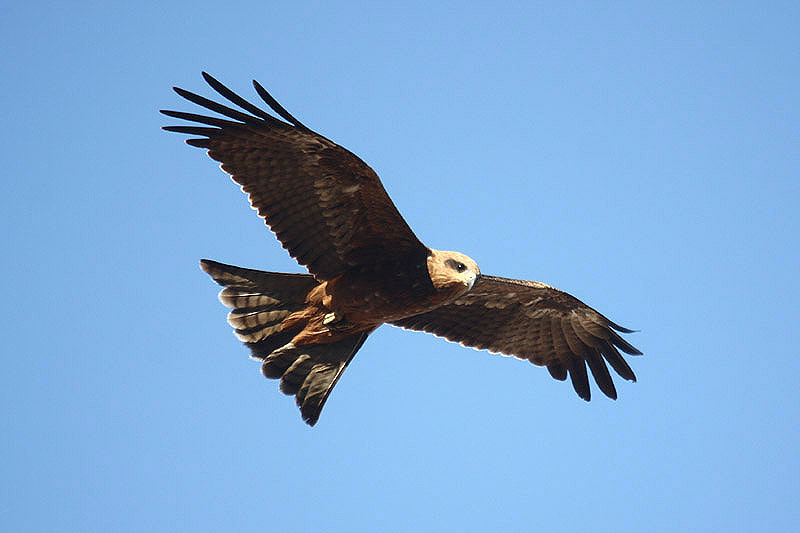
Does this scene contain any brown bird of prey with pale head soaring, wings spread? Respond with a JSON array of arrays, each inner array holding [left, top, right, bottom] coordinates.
[[161, 72, 641, 426]]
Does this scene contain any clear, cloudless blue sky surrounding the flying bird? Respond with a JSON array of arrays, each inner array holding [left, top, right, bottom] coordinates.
[[0, 1, 800, 532]]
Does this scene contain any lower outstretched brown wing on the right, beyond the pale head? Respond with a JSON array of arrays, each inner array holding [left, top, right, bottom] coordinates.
[[393, 276, 642, 401]]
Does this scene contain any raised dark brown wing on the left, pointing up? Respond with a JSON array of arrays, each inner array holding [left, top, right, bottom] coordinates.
[[161, 72, 427, 280]]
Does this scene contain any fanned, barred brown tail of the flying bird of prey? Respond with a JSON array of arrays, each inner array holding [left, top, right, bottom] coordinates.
[[200, 259, 373, 426]]
